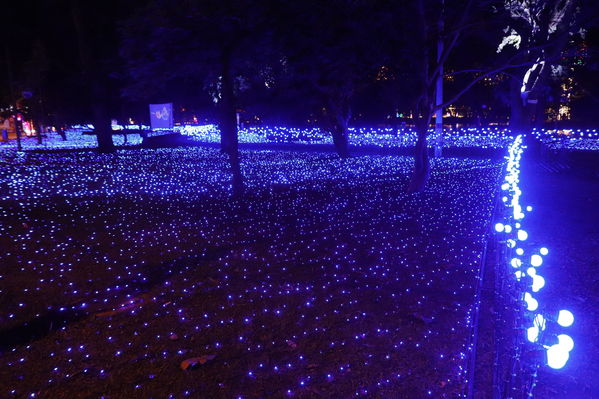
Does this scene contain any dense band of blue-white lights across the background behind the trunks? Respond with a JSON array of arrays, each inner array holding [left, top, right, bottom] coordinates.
[[0, 124, 599, 151]]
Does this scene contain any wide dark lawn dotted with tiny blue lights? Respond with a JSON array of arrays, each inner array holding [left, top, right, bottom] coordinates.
[[0, 148, 502, 398]]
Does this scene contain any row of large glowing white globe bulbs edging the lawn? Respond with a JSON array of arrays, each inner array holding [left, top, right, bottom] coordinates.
[[495, 135, 574, 369]]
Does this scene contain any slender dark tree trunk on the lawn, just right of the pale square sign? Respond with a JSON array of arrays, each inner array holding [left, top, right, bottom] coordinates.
[[220, 52, 244, 196]]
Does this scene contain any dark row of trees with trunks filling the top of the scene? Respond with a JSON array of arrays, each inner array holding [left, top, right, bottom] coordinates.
[[0, 0, 599, 191]]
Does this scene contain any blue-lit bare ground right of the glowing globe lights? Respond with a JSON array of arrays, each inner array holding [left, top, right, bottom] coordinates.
[[521, 160, 599, 399]]
